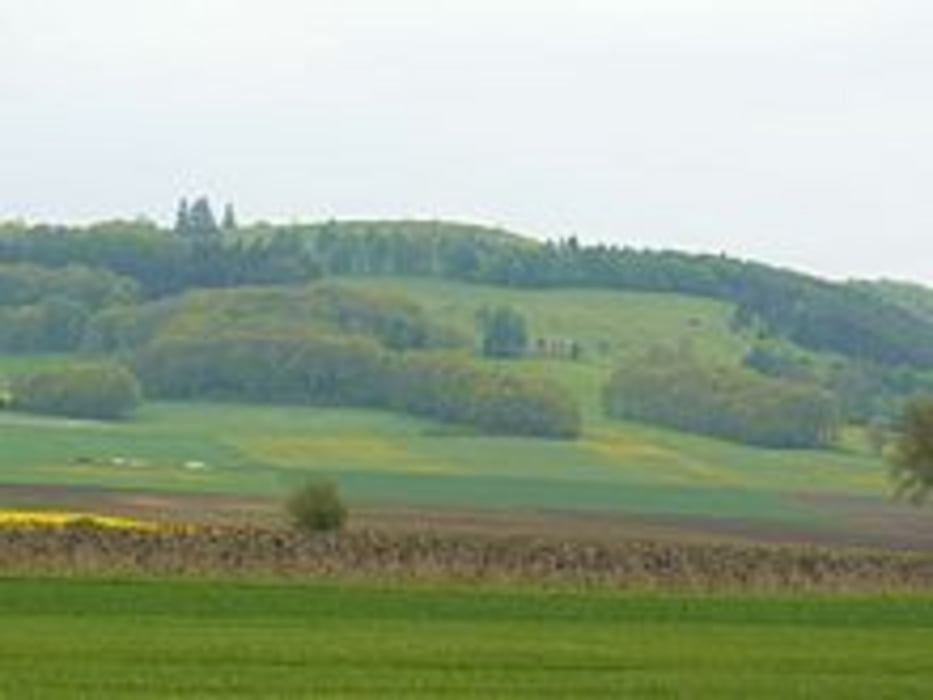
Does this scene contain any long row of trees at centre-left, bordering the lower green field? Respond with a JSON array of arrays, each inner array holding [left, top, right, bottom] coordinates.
[[133, 333, 580, 438]]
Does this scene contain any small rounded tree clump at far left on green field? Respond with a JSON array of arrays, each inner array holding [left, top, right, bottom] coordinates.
[[11, 364, 141, 420]]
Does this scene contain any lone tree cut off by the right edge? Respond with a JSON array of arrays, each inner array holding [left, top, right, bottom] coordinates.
[[893, 397, 933, 505]]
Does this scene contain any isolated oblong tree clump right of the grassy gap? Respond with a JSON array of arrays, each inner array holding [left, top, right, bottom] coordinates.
[[604, 353, 838, 448]]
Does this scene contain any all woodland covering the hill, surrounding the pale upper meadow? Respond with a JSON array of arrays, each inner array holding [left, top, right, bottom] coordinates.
[[0, 198, 933, 447]]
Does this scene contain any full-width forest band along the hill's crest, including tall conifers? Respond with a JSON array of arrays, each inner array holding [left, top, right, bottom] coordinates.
[[0, 210, 933, 368]]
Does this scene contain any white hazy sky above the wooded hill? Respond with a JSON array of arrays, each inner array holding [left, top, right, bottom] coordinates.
[[0, 0, 933, 284]]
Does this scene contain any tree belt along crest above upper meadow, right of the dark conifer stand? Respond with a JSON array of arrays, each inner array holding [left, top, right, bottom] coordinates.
[[289, 222, 933, 367]]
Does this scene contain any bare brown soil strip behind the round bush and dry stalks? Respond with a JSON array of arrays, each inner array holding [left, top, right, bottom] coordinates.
[[0, 484, 933, 552]]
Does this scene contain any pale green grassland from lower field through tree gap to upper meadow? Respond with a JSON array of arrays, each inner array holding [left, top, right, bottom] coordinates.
[[0, 278, 908, 536]]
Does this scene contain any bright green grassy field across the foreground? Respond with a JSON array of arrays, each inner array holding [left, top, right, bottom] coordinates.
[[0, 580, 933, 700]]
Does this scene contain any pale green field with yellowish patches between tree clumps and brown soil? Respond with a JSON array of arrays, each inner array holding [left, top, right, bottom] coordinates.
[[0, 403, 904, 527]]
